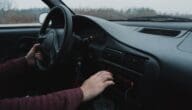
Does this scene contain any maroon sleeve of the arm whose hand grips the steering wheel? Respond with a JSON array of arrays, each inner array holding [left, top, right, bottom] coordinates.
[[0, 57, 29, 75]]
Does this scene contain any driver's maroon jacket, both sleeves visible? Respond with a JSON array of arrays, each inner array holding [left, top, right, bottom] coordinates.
[[0, 58, 83, 110]]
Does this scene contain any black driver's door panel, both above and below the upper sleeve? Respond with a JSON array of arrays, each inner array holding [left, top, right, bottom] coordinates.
[[0, 26, 40, 98]]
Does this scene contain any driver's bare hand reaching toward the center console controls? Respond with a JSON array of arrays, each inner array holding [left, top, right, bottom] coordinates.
[[81, 71, 115, 101]]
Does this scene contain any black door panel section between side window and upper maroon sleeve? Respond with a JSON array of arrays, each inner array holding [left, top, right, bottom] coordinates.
[[0, 27, 40, 62]]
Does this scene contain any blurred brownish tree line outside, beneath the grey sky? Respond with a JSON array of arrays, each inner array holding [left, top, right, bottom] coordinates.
[[0, 8, 192, 24]]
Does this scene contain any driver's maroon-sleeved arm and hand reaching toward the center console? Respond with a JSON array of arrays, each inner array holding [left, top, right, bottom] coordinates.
[[0, 71, 114, 110]]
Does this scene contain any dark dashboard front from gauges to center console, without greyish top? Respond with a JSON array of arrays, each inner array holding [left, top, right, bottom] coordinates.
[[74, 17, 160, 110]]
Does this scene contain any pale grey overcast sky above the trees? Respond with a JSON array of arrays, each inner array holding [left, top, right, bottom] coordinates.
[[10, 0, 192, 14]]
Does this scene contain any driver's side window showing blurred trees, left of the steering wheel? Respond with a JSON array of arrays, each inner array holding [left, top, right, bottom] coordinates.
[[0, 0, 49, 25]]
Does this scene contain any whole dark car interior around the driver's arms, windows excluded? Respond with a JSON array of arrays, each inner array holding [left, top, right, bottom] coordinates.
[[0, 0, 192, 110]]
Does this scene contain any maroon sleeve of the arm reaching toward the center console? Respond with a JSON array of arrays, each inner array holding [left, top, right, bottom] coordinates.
[[0, 88, 83, 110]]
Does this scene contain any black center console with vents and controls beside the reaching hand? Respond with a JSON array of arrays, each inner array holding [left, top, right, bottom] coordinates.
[[74, 34, 160, 110]]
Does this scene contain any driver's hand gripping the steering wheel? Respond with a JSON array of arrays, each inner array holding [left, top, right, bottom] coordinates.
[[25, 44, 43, 65]]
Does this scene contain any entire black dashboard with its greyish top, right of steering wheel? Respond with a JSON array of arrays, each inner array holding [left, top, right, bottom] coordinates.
[[73, 15, 192, 110]]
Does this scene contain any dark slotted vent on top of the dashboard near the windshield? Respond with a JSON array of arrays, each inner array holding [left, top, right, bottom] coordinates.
[[140, 28, 181, 37]]
